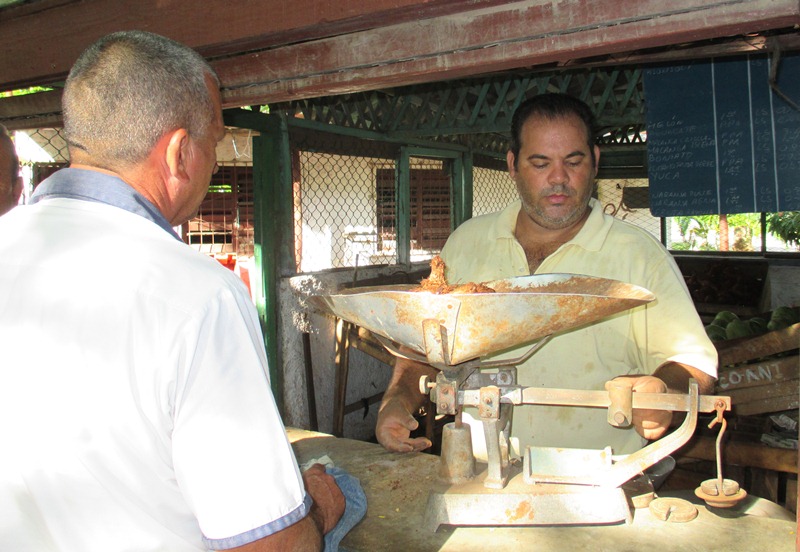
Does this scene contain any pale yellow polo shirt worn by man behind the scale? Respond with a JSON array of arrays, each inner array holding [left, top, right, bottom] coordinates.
[[441, 199, 717, 454]]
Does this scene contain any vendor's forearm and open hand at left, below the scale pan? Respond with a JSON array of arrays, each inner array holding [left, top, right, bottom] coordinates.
[[375, 357, 437, 452]]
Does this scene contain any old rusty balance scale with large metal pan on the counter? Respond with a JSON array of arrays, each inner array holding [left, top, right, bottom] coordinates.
[[310, 274, 746, 531]]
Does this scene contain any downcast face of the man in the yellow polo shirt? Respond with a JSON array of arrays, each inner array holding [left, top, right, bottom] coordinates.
[[507, 115, 600, 230]]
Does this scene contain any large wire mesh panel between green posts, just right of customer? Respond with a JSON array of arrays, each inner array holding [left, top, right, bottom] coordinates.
[[290, 129, 399, 273]]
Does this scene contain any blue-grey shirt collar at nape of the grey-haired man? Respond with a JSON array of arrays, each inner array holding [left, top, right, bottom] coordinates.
[[30, 168, 182, 241]]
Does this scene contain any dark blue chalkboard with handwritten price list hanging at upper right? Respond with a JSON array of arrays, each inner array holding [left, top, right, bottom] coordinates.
[[643, 55, 800, 217]]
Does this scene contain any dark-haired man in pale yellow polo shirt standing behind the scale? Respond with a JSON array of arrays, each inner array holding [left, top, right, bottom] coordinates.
[[376, 94, 717, 460]]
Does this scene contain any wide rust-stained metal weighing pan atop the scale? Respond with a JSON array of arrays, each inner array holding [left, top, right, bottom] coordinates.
[[309, 274, 655, 365]]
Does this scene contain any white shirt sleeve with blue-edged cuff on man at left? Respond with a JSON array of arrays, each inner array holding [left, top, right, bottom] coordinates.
[[172, 282, 310, 548]]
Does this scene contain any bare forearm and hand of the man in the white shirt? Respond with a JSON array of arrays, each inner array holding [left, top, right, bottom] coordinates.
[[222, 464, 345, 552]]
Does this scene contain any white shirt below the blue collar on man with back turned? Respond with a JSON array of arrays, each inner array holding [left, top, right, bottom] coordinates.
[[0, 171, 311, 552]]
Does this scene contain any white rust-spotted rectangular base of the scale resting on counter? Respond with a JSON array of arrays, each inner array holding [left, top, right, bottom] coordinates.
[[425, 470, 633, 531]]
